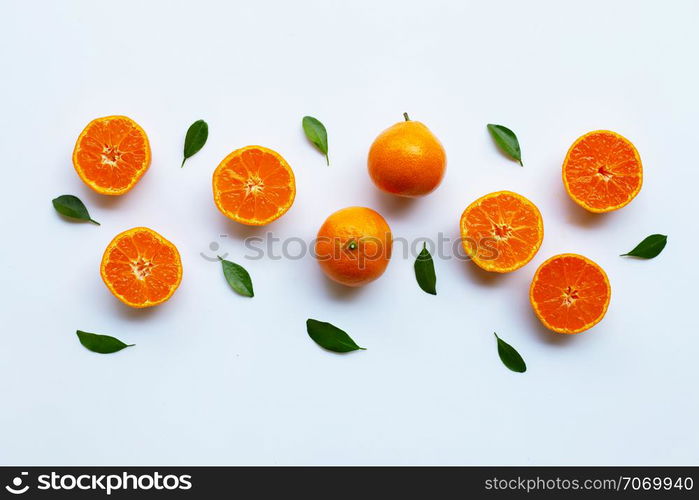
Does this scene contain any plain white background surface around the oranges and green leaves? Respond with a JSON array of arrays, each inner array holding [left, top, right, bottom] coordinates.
[[0, 0, 699, 464]]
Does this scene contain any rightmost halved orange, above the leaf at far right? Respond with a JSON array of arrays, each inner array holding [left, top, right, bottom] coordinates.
[[563, 130, 643, 213]]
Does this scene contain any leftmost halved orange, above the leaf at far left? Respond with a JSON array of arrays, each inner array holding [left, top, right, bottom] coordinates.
[[73, 116, 150, 195]]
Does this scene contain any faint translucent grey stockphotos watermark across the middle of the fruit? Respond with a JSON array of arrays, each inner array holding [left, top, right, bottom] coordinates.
[[199, 232, 498, 262]]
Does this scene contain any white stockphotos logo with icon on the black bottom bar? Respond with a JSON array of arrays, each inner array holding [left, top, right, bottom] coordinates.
[[5, 472, 192, 495]]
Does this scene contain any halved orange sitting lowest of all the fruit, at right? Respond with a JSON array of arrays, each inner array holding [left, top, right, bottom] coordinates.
[[529, 253, 612, 333]]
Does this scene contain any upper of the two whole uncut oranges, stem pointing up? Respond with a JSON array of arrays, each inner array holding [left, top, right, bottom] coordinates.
[[368, 113, 447, 197]]
